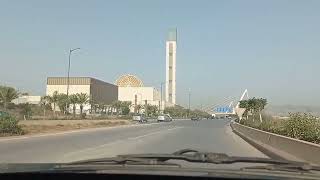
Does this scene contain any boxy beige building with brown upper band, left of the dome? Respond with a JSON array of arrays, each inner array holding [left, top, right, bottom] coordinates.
[[46, 77, 118, 110]]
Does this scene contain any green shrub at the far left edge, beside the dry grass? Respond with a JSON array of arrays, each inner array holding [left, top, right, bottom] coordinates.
[[0, 115, 23, 136]]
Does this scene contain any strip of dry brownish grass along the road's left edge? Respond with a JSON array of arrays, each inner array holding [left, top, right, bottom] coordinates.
[[19, 120, 132, 134]]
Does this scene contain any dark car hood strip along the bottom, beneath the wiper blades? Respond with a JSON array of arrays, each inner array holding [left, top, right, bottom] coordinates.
[[0, 163, 320, 179]]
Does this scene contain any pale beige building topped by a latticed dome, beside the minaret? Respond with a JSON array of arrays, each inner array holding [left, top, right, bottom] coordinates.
[[116, 74, 160, 111]]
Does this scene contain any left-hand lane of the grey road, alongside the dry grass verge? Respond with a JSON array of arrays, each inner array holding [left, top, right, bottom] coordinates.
[[0, 123, 178, 163]]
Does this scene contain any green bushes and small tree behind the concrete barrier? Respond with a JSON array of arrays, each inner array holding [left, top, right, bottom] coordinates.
[[237, 98, 320, 144]]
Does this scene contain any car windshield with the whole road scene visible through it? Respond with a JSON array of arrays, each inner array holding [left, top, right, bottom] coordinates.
[[0, 0, 320, 177]]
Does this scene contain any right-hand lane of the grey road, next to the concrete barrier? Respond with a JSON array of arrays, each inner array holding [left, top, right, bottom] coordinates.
[[61, 120, 266, 162]]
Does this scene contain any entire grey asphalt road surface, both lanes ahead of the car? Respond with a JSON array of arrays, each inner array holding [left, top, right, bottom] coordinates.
[[0, 120, 264, 163]]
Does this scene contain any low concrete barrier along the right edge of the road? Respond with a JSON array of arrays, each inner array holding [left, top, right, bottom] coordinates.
[[231, 122, 320, 165]]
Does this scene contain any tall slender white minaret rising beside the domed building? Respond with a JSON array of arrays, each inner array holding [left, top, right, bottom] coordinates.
[[165, 28, 177, 105]]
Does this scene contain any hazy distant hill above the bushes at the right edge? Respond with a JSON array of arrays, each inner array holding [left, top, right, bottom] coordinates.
[[265, 105, 320, 116]]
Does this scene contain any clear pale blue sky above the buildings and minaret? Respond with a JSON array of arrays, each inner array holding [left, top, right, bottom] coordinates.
[[0, 0, 320, 107]]
